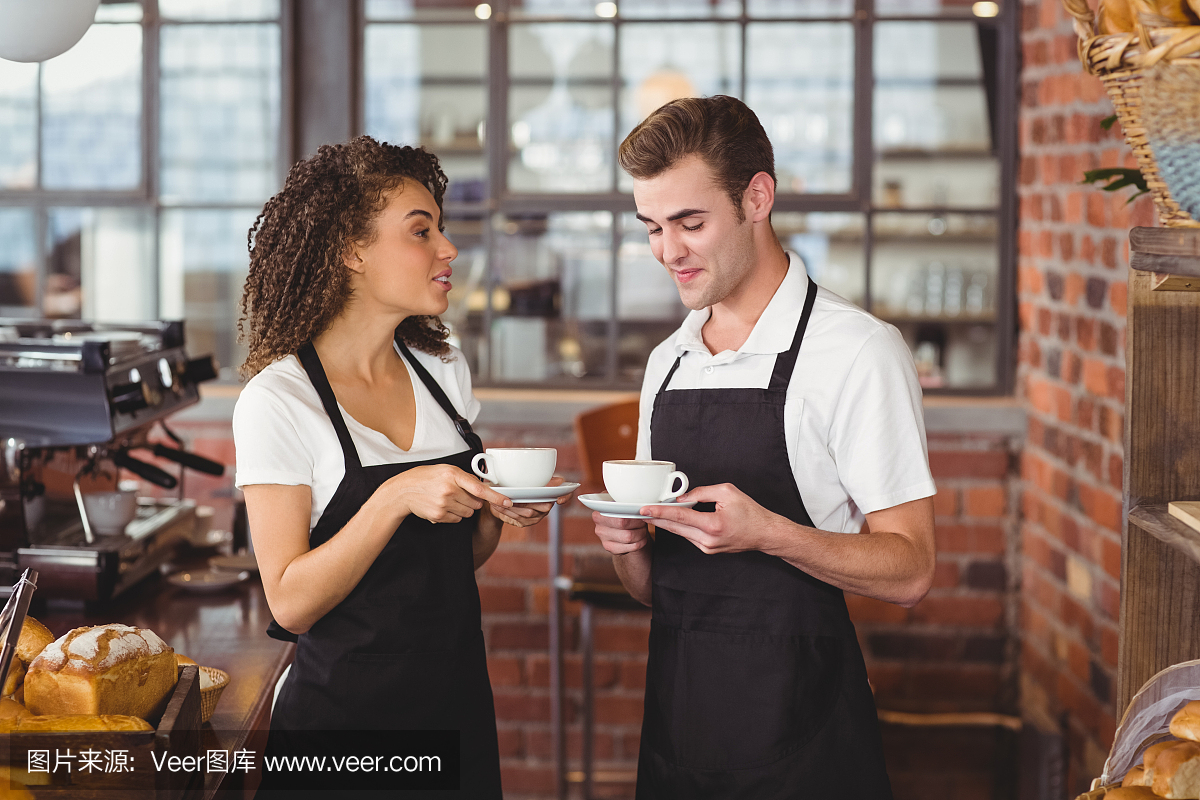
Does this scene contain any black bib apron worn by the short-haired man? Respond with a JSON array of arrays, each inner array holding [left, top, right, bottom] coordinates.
[[637, 277, 892, 800]]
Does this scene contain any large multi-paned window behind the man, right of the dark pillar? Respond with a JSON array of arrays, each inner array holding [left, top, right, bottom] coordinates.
[[362, 0, 1018, 392]]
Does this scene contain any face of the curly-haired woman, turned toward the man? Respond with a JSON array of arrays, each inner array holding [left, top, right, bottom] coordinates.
[[347, 180, 458, 317]]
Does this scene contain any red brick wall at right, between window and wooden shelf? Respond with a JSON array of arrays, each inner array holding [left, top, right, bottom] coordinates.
[[1018, 0, 1154, 796]]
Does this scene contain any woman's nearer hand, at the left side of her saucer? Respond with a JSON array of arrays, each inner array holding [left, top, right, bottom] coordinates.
[[386, 464, 512, 522]]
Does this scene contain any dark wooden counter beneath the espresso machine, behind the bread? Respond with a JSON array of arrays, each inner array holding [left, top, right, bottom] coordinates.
[[30, 563, 293, 800]]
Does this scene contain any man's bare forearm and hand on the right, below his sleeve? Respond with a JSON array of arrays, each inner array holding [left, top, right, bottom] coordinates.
[[643, 483, 937, 608]]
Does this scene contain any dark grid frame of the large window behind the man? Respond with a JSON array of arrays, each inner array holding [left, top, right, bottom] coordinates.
[[358, 0, 1020, 397]]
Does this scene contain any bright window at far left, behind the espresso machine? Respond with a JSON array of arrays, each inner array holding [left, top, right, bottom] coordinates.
[[0, 0, 283, 378]]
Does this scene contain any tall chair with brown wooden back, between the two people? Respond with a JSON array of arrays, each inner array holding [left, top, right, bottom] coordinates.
[[554, 399, 649, 800]]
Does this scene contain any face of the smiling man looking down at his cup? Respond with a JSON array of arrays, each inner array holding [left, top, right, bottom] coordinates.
[[634, 156, 755, 311]]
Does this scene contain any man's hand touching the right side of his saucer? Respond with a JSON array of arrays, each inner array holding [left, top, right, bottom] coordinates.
[[643, 483, 785, 553]]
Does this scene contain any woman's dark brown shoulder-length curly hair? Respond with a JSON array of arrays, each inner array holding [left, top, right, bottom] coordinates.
[[238, 136, 450, 379]]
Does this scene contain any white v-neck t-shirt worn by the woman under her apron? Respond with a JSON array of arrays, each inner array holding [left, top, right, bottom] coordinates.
[[233, 347, 479, 529]]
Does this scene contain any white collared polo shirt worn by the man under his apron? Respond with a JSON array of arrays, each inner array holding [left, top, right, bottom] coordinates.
[[637, 252, 936, 534]]
